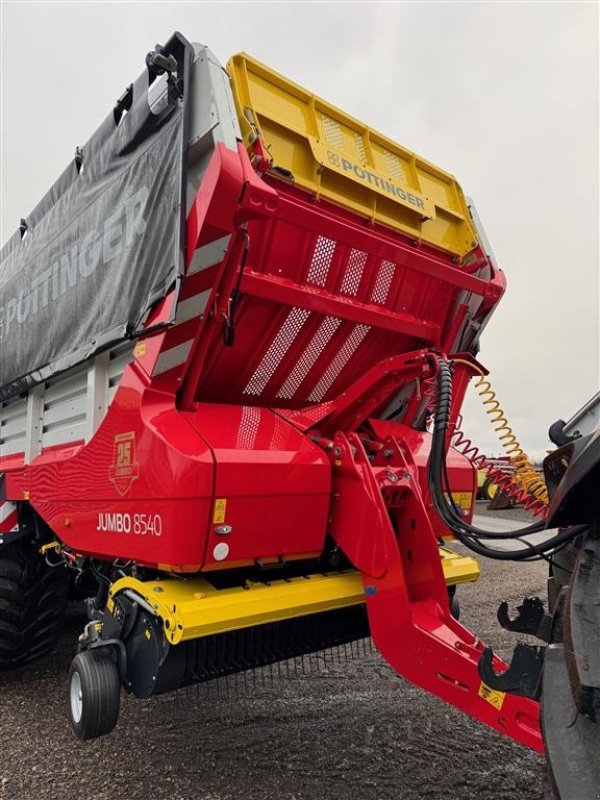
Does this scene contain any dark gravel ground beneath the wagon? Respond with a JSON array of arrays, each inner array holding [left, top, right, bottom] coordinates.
[[0, 504, 546, 800]]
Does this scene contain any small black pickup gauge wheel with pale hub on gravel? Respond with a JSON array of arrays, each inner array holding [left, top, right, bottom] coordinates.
[[68, 648, 121, 739]]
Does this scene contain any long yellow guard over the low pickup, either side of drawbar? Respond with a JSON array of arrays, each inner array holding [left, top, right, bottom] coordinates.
[[107, 547, 479, 644]]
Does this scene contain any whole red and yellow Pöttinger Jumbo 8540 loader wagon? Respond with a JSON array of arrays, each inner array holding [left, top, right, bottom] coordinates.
[[0, 34, 599, 796]]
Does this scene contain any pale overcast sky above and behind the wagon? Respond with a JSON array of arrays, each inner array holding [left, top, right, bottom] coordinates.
[[0, 0, 600, 454]]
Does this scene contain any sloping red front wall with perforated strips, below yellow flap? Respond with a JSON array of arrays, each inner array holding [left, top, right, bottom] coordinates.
[[192, 177, 460, 410]]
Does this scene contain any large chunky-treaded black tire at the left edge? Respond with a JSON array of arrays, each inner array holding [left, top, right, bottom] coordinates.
[[0, 542, 69, 672]]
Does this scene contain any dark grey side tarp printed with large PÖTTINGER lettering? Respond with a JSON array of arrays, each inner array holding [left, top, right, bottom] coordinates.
[[0, 36, 190, 401]]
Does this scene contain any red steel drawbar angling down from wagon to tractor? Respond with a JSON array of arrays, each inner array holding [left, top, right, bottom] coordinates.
[[330, 424, 543, 752]]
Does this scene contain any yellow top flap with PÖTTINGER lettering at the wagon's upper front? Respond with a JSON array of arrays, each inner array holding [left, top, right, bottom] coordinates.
[[227, 53, 477, 258]]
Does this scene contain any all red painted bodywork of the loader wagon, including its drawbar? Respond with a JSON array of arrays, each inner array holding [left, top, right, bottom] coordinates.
[[0, 139, 542, 750]]
